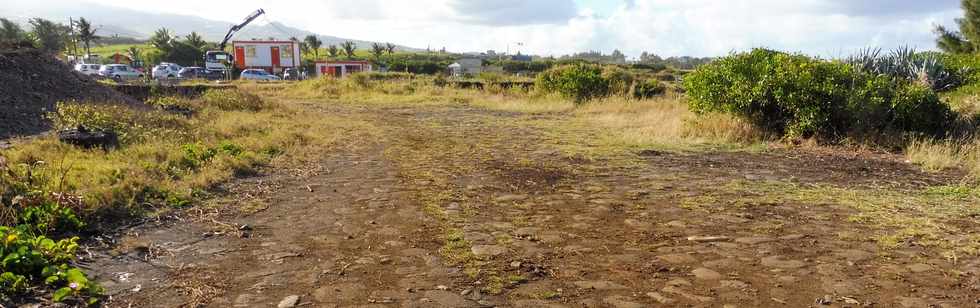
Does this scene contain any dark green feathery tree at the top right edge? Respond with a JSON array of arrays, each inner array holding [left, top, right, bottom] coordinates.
[[935, 0, 980, 53]]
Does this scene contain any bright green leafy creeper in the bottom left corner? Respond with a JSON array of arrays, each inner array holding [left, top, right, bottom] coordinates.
[[0, 157, 101, 303]]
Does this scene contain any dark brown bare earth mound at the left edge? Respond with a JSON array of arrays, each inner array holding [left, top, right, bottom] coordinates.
[[0, 49, 136, 140]]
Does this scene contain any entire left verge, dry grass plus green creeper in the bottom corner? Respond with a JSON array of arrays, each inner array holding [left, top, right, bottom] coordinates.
[[0, 90, 372, 303]]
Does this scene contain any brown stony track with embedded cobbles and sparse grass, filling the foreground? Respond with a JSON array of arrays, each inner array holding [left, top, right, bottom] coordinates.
[[87, 103, 980, 307]]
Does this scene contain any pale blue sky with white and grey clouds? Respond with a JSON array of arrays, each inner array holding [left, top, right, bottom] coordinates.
[[28, 0, 962, 57]]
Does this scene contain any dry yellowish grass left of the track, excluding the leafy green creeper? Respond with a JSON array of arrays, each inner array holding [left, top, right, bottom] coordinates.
[[0, 90, 375, 220]]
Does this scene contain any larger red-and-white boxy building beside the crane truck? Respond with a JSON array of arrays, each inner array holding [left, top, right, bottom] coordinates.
[[231, 40, 302, 74]]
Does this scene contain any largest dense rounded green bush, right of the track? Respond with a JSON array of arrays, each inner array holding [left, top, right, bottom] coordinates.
[[684, 49, 950, 139]]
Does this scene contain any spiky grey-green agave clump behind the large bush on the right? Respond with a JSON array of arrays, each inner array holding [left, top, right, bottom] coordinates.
[[845, 47, 968, 91]]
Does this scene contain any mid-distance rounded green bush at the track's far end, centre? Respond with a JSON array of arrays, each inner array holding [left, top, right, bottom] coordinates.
[[535, 64, 609, 104]]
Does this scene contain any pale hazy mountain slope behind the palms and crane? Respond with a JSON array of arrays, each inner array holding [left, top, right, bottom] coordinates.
[[0, 1, 419, 51]]
